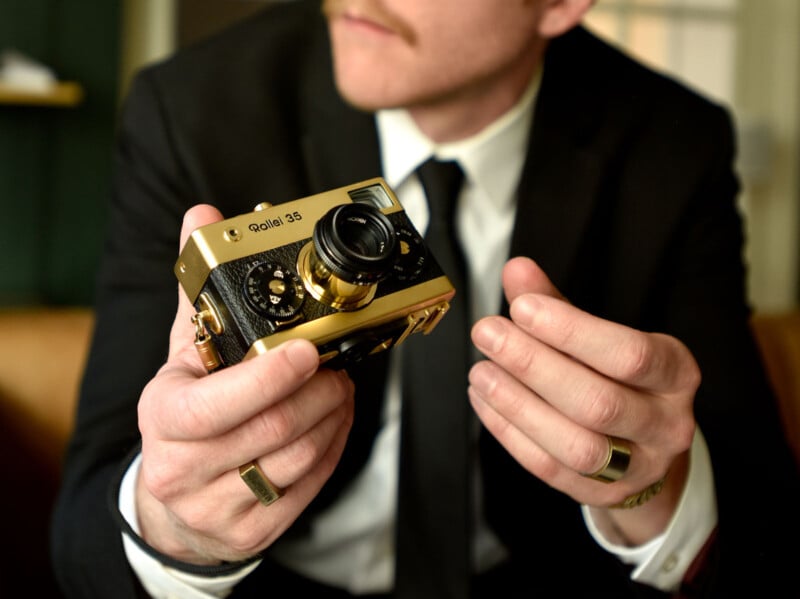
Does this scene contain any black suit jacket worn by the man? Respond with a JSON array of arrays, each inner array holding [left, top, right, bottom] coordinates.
[[53, 1, 800, 597]]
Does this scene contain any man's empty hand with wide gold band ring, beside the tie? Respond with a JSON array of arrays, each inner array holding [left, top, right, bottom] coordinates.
[[469, 258, 700, 544]]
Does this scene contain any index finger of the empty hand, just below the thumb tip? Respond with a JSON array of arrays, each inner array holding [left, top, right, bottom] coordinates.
[[511, 294, 699, 394]]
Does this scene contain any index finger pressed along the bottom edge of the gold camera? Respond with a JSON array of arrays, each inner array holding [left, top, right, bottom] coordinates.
[[143, 339, 319, 441]]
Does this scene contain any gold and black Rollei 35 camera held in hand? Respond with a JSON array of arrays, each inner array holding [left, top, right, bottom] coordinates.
[[175, 178, 455, 371]]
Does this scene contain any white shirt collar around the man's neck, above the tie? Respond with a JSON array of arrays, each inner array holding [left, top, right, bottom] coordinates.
[[376, 69, 541, 209]]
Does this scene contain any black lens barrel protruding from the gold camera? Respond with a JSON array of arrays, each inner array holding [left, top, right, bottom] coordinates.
[[314, 203, 396, 285]]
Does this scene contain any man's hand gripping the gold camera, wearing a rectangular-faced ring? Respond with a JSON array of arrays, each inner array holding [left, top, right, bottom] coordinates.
[[136, 205, 354, 565]]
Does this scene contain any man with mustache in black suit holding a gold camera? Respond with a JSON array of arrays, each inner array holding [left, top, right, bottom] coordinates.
[[54, 0, 800, 597]]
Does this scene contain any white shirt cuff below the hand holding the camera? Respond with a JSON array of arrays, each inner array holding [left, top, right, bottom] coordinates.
[[118, 454, 261, 599]]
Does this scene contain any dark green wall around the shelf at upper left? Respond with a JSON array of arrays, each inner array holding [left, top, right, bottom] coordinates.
[[0, 0, 122, 306]]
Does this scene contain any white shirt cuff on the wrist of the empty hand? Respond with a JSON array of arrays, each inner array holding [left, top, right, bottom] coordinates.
[[581, 428, 717, 592]]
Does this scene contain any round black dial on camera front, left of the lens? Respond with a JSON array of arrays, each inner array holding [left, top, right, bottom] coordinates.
[[244, 262, 306, 320]]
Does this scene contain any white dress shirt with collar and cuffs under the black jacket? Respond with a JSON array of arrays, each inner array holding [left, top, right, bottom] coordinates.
[[120, 68, 717, 598]]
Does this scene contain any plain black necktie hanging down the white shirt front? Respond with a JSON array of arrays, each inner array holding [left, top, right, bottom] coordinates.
[[395, 159, 470, 599]]
